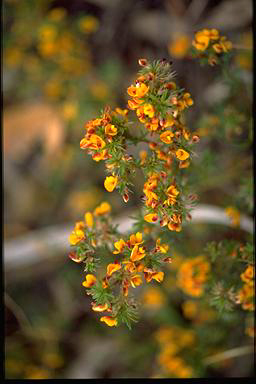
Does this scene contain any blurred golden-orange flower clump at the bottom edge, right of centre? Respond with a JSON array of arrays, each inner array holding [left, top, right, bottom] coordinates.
[[155, 326, 196, 378]]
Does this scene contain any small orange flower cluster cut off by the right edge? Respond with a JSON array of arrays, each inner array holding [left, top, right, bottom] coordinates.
[[236, 265, 255, 311]]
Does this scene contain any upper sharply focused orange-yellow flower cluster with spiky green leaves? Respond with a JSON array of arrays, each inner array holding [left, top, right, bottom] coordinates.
[[80, 59, 199, 226]]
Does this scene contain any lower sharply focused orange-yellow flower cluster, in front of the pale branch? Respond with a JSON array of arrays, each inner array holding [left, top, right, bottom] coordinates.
[[69, 202, 171, 327]]
